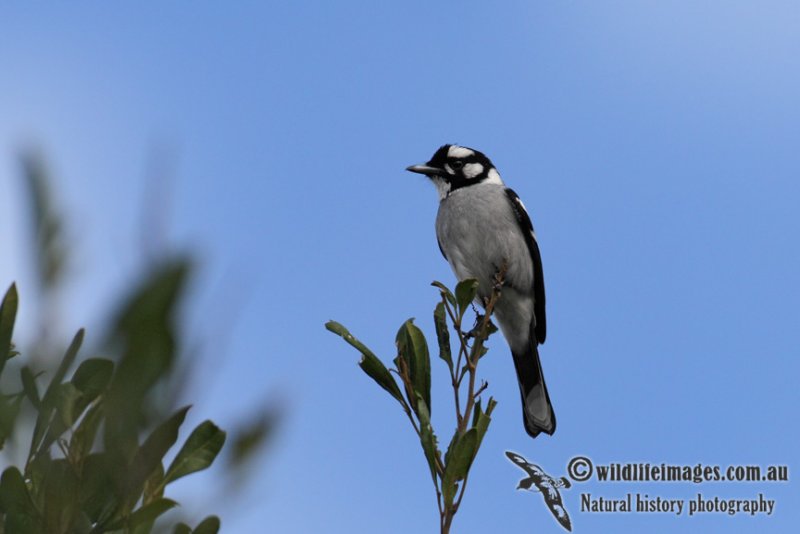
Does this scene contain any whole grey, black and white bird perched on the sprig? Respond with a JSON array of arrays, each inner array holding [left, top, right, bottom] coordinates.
[[406, 145, 556, 438]]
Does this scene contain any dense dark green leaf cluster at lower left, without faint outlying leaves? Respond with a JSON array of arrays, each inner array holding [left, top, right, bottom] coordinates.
[[0, 274, 225, 534]]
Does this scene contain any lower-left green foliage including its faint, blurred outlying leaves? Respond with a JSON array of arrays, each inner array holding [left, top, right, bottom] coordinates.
[[0, 154, 279, 534]]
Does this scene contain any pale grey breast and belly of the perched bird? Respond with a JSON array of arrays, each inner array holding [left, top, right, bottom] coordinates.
[[436, 184, 533, 296]]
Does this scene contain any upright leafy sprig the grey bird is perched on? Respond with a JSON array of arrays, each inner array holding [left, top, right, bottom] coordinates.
[[325, 276, 504, 534]]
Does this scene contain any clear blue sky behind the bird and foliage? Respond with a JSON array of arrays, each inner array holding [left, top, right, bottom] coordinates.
[[0, 0, 800, 533]]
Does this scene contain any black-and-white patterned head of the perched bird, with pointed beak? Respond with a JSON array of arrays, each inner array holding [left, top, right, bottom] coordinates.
[[406, 145, 503, 199]]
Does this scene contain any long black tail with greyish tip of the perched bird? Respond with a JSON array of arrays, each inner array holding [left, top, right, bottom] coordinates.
[[512, 344, 556, 438]]
